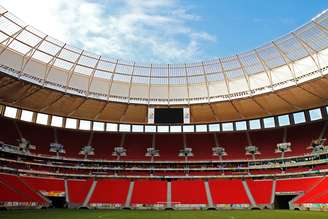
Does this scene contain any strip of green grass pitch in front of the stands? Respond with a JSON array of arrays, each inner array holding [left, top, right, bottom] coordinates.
[[0, 210, 328, 219]]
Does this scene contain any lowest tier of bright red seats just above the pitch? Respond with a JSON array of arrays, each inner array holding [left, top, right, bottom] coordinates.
[[0, 173, 328, 208]]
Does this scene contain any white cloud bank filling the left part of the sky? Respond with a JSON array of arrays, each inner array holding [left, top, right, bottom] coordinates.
[[0, 0, 216, 63]]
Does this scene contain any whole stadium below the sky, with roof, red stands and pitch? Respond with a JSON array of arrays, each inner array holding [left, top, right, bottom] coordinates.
[[0, 1, 328, 218]]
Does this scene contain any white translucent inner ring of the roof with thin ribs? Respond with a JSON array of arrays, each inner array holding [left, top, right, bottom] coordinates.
[[0, 4, 328, 105]]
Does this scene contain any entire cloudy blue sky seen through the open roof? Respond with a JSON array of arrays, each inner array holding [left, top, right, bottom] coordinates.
[[0, 0, 328, 63]]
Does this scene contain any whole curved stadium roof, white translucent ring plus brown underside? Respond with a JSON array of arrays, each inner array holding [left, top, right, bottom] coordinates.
[[0, 8, 328, 123]]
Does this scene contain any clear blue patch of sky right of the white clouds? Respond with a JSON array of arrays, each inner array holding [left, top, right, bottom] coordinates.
[[185, 0, 328, 57]]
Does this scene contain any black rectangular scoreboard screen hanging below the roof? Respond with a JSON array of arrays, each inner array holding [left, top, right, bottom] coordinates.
[[155, 108, 183, 124]]
